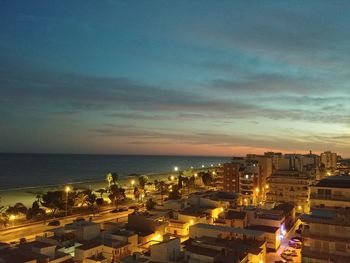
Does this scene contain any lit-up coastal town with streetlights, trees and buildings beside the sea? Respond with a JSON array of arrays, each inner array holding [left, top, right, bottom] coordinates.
[[0, 151, 350, 263]]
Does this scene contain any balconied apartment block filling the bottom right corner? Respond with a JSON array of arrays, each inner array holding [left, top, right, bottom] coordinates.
[[300, 209, 350, 263]]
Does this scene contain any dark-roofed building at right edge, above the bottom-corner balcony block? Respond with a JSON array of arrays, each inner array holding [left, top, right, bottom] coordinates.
[[310, 175, 350, 209]]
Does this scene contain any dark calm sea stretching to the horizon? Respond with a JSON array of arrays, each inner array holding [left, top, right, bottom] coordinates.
[[0, 154, 230, 190]]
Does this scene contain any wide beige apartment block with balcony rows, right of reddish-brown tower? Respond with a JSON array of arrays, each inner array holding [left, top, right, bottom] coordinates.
[[267, 170, 312, 213]]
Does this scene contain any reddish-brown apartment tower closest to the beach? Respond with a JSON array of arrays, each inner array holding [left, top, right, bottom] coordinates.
[[217, 163, 242, 193]]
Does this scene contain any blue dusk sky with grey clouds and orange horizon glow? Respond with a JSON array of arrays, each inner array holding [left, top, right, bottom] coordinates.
[[0, 0, 350, 157]]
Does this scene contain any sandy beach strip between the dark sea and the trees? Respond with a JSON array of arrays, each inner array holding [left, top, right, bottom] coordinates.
[[0, 167, 216, 208]]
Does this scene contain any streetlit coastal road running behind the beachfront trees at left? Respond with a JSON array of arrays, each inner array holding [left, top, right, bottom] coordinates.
[[0, 209, 134, 243]]
